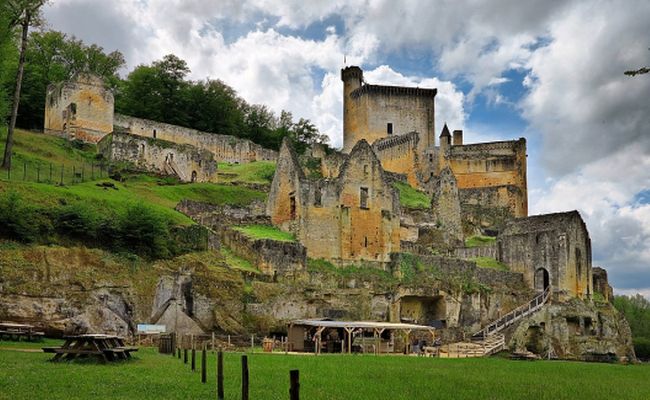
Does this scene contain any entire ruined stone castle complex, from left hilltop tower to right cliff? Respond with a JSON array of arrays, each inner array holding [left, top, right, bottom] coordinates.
[[38, 66, 634, 359]]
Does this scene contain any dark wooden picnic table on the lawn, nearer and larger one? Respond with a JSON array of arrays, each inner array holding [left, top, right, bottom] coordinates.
[[43, 334, 138, 362]]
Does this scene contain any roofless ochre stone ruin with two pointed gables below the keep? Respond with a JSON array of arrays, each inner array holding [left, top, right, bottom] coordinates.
[[267, 141, 400, 263]]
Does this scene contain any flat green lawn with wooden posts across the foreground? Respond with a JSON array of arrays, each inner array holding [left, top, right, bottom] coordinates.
[[0, 349, 650, 400]]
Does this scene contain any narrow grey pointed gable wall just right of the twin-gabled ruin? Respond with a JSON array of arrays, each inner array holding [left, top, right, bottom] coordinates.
[[432, 167, 463, 247]]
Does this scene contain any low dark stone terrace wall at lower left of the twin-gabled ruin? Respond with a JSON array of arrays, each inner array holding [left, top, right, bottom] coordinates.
[[221, 229, 307, 278]]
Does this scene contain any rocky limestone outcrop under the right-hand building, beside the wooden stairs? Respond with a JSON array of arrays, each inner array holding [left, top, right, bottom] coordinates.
[[509, 299, 636, 362]]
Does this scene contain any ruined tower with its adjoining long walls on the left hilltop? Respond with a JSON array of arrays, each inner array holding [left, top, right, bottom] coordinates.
[[44, 74, 277, 182]]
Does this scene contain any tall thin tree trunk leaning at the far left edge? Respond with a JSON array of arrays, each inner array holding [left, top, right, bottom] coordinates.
[[0, 0, 47, 169]]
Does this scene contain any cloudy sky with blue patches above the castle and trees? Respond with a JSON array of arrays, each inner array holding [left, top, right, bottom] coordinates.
[[45, 0, 650, 297]]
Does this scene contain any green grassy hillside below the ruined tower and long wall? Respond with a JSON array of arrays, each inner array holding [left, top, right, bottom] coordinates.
[[0, 130, 274, 256]]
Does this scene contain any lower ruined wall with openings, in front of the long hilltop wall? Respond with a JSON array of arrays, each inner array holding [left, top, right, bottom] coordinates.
[[97, 132, 217, 182]]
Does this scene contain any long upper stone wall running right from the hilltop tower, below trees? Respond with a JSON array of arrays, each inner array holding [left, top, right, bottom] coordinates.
[[115, 114, 278, 163]]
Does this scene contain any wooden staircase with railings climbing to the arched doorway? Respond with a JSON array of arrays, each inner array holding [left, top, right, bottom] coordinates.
[[439, 287, 551, 358]]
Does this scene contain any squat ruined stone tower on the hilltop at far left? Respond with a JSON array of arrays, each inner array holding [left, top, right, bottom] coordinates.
[[43, 74, 114, 143]]
